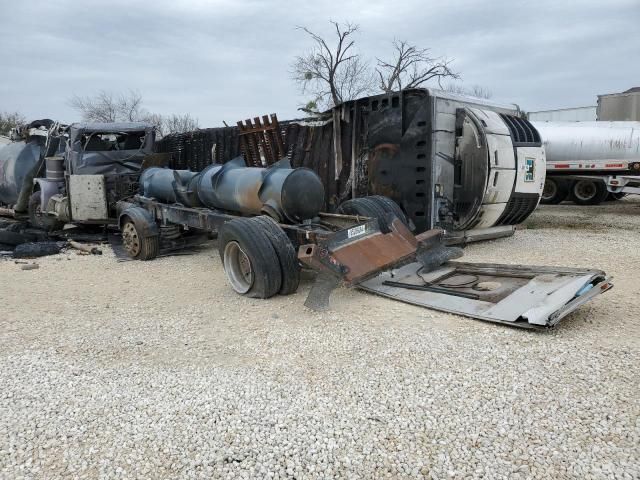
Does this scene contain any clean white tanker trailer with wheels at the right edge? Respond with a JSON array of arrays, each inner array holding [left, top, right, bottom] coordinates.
[[531, 122, 640, 205]]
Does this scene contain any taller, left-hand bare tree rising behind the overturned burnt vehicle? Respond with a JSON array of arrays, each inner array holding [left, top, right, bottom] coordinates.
[[292, 20, 373, 108]]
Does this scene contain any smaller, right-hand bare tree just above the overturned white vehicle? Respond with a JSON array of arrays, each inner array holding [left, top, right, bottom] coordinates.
[[376, 40, 460, 92]]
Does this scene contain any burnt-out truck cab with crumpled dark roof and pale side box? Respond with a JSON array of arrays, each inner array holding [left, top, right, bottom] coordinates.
[[5, 123, 155, 230]]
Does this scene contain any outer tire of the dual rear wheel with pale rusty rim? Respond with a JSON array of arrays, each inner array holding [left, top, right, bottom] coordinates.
[[218, 218, 282, 298]]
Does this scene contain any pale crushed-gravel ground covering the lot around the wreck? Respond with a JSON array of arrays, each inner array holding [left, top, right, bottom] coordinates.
[[0, 200, 640, 479]]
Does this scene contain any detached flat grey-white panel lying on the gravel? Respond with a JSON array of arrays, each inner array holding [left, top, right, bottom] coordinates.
[[358, 262, 613, 328]]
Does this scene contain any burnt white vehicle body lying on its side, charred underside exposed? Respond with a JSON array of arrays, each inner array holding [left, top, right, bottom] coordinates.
[[157, 89, 545, 241]]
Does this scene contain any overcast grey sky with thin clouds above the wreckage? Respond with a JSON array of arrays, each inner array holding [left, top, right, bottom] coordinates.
[[0, 0, 640, 127]]
